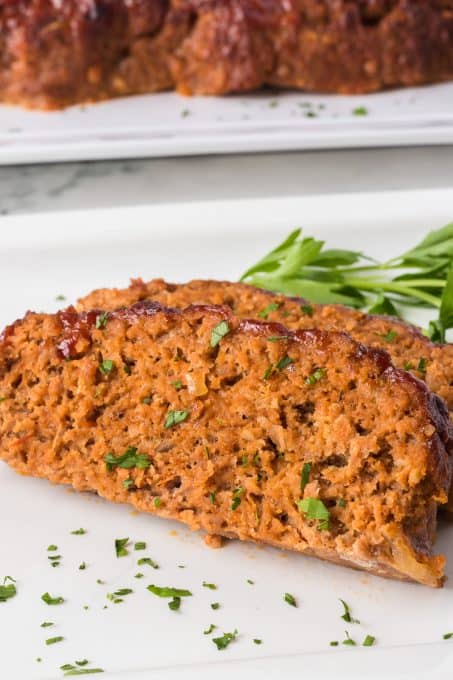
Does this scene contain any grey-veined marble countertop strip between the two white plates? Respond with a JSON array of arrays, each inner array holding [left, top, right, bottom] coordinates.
[[0, 146, 453, 214]]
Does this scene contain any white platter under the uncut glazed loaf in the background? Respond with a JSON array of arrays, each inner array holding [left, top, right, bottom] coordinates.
[[0, 83, 453, 164]]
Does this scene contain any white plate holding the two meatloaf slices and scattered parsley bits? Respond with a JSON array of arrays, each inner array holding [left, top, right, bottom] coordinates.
[[0, 191, 453, 680]]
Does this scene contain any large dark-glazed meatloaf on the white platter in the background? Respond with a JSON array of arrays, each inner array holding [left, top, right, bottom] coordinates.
[[0, 0, 453, 109]]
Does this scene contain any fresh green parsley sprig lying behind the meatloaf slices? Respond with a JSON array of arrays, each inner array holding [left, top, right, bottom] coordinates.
[[241, 222, 453, 342]]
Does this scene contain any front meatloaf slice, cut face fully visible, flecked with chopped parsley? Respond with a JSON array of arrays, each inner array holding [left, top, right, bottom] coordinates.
[[0, 302, 452, 586]]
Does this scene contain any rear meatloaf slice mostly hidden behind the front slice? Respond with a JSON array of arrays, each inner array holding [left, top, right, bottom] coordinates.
[[78, 279, 453, 412]]
